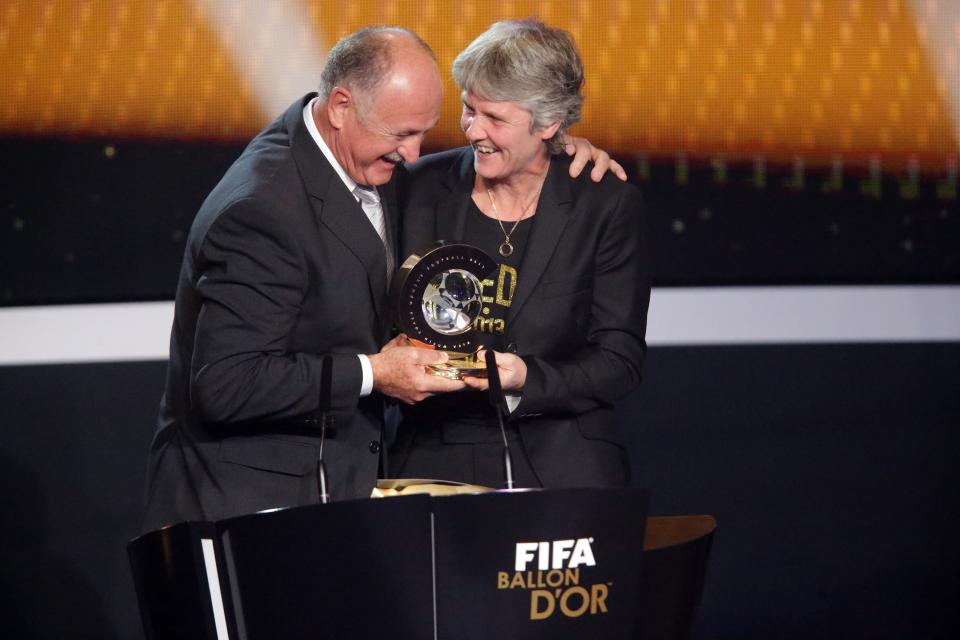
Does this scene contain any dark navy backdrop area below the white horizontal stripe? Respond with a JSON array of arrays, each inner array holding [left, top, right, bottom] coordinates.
[[0, 344, 960, 640]]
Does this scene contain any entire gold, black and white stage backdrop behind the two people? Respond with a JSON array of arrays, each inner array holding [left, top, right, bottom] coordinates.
[[0, 0, 960, 640]]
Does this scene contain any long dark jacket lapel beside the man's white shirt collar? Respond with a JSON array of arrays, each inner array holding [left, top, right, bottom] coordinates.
[[284, 95, 386, 318]]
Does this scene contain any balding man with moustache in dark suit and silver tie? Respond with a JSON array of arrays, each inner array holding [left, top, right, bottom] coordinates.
[[143, 28, 462, 531]]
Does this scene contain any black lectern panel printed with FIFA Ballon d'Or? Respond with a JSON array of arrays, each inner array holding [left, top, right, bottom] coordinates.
[[433, 489, 649, 640]]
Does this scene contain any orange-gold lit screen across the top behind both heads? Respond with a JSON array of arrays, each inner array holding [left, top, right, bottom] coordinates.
[[0, 0, 960, 172]]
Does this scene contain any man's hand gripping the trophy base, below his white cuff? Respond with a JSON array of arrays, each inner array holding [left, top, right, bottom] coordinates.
[[368, 338, 466, 404]]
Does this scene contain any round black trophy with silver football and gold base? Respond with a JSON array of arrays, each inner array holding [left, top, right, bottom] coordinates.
[[390, 241, 497, 380]]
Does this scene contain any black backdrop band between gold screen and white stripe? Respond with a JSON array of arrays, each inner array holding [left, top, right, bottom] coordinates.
[[0, 138, 960, 306]]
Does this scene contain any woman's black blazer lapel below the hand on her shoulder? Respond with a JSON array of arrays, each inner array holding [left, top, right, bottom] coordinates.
[[507, 162, 573, 326]]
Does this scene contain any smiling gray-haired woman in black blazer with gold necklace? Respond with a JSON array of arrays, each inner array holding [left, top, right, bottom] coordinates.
[[390, 20, 650, 487]]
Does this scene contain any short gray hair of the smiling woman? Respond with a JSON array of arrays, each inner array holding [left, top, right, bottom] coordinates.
[[453, 19, 583, 154]]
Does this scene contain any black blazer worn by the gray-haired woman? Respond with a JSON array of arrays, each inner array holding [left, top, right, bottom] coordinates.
[[398, 148, 650, 487]]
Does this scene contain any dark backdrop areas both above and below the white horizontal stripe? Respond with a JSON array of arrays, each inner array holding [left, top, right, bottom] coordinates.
[[0, 139, 960, 640]]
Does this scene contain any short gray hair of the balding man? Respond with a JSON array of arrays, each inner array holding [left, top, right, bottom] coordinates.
[[319, 27, 436, 110]]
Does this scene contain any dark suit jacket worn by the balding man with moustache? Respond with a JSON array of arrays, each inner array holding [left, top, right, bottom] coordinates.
[[143, 91, 397, 530]]
